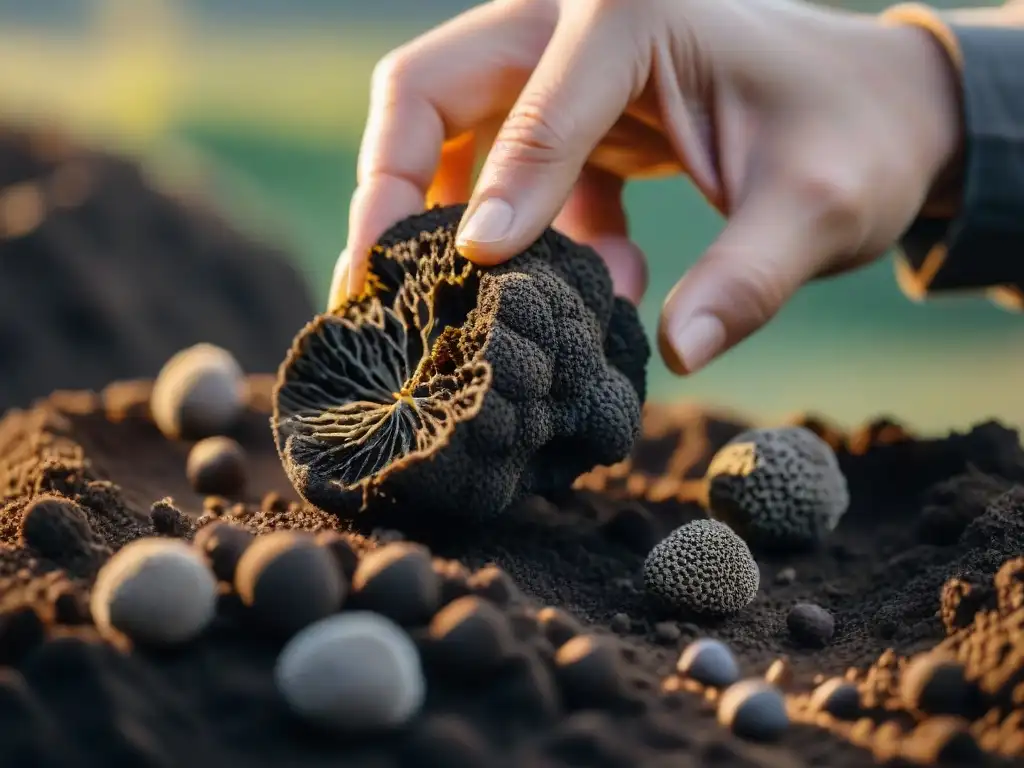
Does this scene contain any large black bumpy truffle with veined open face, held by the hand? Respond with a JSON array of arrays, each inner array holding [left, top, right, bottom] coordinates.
[[272, 206, 650, 518]]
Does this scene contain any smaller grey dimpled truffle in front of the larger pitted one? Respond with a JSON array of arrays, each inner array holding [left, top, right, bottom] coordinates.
[[644, 519, 761, 614]]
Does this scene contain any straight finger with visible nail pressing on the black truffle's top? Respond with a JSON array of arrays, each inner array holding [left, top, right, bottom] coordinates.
[[456, 3, 643, 264]]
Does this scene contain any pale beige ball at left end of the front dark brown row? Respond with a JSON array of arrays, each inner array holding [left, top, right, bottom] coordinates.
[[90, 538, 217, 645]]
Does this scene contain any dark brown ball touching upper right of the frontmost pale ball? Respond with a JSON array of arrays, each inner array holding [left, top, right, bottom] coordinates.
[[352, 542, 440, 627]]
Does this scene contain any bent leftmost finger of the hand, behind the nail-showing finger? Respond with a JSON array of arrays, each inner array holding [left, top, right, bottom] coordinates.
[[332, 3, 556, 302]]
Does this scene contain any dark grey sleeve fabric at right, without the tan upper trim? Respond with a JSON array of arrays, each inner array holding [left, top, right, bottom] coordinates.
[[900, 26, 1024, 303]]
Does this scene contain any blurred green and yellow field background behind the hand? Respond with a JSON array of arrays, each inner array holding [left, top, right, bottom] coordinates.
[[0, 0, 1011, 431]]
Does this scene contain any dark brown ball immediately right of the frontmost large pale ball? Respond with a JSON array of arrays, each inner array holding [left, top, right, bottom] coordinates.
[[429, 596, 514, 674]]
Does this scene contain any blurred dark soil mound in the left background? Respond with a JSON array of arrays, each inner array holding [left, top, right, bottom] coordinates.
[[0, 126, 313, 410]]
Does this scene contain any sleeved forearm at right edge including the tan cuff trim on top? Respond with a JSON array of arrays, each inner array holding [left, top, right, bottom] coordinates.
[[885, 0, 1024, 303]]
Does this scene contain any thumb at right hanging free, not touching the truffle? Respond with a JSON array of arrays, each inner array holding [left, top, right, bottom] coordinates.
[[657, 189, 831, 375]]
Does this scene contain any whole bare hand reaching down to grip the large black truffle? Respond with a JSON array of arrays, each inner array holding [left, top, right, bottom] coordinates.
[[333, 0, 961, 374]]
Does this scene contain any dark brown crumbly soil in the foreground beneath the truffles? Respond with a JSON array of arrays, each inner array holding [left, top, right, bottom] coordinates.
[[0, 377, 1024, 768]]
